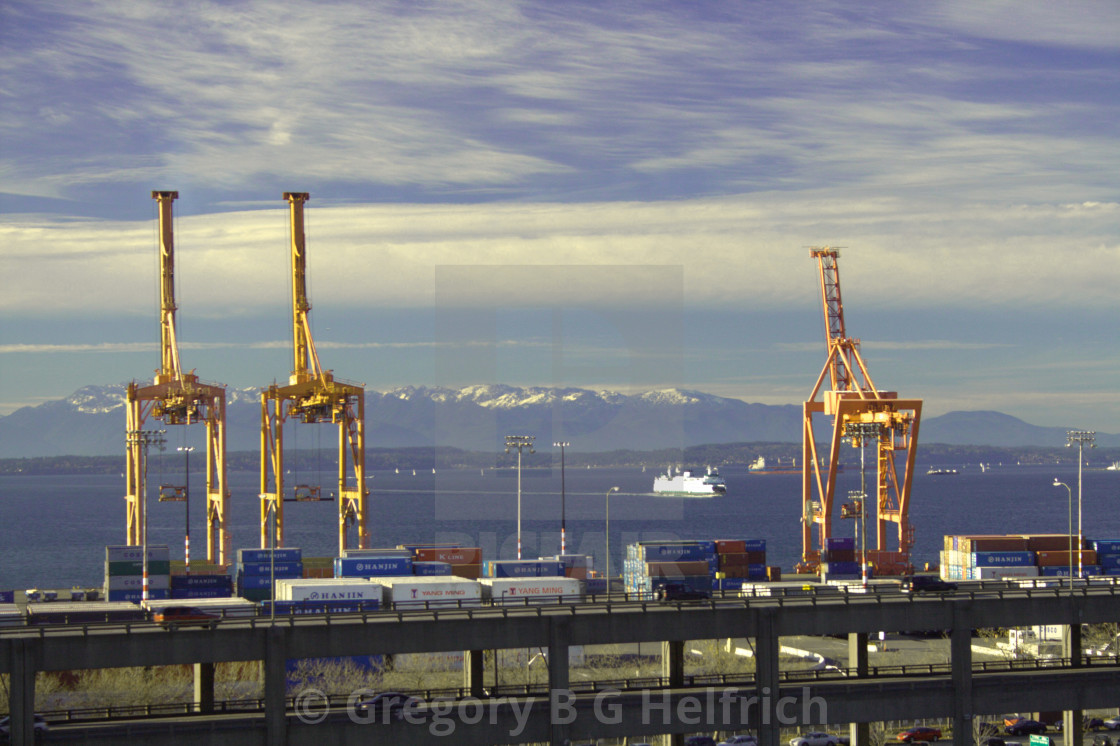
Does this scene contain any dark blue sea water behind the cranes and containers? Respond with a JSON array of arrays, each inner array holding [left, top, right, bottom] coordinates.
[[0, 464, 1120, 589]]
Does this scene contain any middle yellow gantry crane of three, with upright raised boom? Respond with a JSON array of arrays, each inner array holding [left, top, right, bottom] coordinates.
[[260, 192, 370, 554]]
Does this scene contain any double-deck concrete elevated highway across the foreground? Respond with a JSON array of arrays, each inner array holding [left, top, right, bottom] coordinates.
[[0, 584, 1120, 746]]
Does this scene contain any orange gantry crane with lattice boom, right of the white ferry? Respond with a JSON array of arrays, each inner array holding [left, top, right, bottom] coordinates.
[[797, 246, 922, 575]]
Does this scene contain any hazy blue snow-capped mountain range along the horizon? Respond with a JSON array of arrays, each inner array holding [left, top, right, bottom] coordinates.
[[0, 384, 1106, 458]]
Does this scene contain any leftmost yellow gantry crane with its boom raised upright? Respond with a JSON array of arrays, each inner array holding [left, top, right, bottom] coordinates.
[[124, 192, 231, 566]]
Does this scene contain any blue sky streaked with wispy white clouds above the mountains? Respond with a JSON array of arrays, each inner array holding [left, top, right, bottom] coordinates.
[[0, 0, 1120, 432]]
